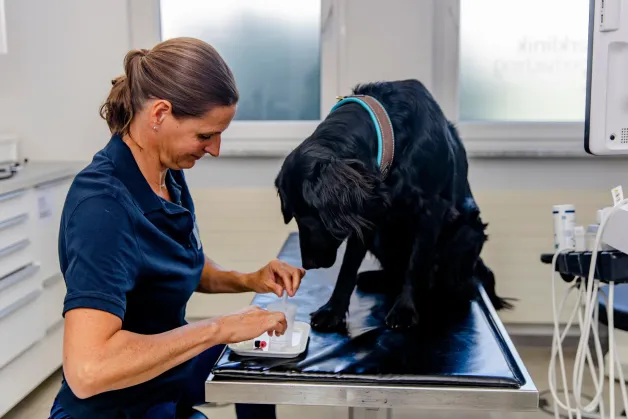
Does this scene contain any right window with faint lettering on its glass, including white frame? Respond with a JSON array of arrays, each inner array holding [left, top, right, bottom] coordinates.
[[431, 0, 589, 157]]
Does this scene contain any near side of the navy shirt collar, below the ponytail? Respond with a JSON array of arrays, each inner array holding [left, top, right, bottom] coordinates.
[[105, 135, 163, 213]]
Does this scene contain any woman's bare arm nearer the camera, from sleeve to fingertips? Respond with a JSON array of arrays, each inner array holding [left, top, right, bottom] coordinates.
[[63, 307, 286, 398]]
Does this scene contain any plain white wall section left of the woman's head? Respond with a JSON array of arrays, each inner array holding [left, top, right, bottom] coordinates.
[[0, 0, 129, 160]]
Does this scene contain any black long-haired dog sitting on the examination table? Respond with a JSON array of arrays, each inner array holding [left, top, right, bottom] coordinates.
[[275, 80, 510, 331]]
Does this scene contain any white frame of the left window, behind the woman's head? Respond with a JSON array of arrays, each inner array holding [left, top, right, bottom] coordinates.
[[127, 0, 345, 157]]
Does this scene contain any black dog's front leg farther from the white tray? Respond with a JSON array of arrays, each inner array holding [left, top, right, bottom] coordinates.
[[386, 199, 449, 329]]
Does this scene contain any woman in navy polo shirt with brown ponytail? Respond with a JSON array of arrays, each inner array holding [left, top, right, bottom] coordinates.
[[51, 38, 304, 419]]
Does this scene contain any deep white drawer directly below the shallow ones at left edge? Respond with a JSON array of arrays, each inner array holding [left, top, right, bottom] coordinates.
[[0, 289, 45, 368]]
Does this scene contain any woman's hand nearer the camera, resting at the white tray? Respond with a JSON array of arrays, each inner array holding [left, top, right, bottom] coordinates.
[[216, 306, 288, 344]]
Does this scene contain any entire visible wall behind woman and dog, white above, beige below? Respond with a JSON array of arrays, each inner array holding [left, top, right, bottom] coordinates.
[[0, 0, 628, 323]]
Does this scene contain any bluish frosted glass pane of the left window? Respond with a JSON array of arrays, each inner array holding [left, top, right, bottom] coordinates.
[[160, 0, 321, 121]]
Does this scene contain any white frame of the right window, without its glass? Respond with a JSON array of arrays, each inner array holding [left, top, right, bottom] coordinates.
[[433, 0, 587, 157]]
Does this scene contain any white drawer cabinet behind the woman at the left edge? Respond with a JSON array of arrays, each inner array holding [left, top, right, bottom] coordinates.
[[0, 165, 76, 417]]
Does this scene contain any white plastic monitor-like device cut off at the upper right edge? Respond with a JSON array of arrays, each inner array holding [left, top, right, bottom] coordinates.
[[584, 0, 628, 155]]
